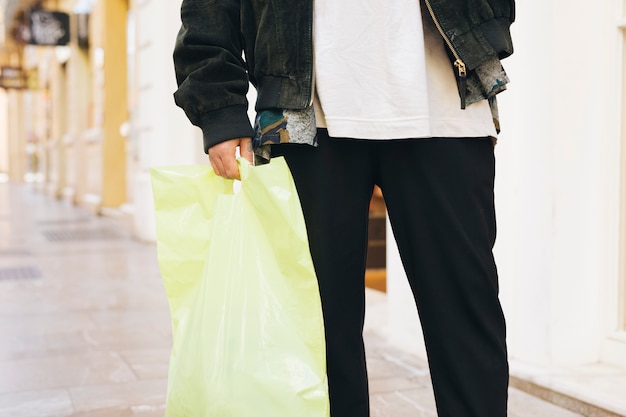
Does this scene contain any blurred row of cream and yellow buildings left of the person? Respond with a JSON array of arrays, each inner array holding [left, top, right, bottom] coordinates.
[[0, 0, 201, 241]]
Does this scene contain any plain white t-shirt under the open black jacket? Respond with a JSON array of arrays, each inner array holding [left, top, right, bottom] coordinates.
[[313, 0, 496, 139]]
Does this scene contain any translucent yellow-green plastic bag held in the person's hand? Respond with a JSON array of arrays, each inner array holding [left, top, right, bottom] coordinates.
[[151, 158, 329, 417]]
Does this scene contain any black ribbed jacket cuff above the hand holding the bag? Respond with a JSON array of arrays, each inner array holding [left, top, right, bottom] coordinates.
[[199, 105, 254, 153]]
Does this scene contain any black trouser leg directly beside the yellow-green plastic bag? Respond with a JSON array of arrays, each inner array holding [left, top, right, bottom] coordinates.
[[272, 130, 373, 417]]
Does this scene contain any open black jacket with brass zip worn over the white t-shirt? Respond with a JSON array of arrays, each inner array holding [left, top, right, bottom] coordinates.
[[174, 0, 515, 151]]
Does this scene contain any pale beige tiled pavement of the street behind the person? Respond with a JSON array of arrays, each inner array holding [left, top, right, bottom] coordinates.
[[0, 184, 582, 417]]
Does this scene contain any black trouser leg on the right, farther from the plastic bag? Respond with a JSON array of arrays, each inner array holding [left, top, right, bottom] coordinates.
[[376, 139, 508, 417]]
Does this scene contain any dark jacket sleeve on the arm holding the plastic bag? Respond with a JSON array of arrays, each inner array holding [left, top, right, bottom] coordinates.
[[174, 0, 253, 152]]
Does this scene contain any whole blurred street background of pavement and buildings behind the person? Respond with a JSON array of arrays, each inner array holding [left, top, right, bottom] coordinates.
[[0, 0, 626, 417]]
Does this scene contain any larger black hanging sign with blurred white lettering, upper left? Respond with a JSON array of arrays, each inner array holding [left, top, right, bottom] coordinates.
[[26, 9, 70, 46]]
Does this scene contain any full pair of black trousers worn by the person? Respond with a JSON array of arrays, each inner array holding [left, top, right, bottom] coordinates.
[[272, 129, 508, 417]]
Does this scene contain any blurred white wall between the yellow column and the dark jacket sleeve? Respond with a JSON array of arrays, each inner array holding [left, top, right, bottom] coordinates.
[[128, 0, 206, 240]]
